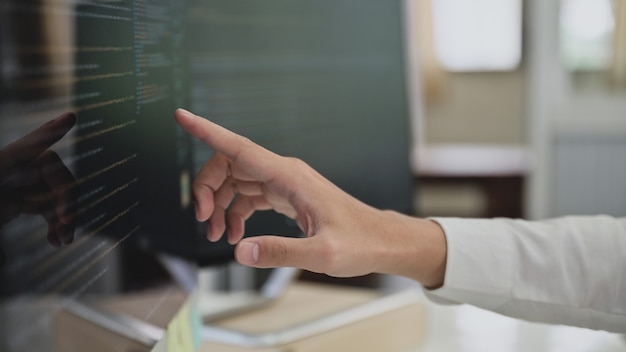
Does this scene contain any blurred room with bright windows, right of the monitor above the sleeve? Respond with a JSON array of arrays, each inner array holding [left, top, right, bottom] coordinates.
[[409, 0, 626, 223]]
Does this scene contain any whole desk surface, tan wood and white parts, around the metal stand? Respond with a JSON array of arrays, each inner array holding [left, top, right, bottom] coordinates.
[[57, 284, 626, 352]]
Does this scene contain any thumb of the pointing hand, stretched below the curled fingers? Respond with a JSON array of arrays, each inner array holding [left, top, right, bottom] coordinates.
[[235, 236, 319, 269]]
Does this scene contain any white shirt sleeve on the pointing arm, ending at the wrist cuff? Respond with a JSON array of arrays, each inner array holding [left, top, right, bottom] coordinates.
[[427, 216, 626, 333]]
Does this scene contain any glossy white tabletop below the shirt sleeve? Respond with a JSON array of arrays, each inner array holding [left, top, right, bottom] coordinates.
[[413, 298, 626, 352]]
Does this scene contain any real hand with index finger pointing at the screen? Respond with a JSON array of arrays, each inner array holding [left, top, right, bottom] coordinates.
[[175, 109, 445, 286]]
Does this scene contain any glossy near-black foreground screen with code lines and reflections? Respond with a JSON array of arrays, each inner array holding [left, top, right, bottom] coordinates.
[[0, 0, 193, 351]]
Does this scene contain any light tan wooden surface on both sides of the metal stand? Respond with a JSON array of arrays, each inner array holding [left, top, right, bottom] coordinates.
[[202, 283, 426, 352]]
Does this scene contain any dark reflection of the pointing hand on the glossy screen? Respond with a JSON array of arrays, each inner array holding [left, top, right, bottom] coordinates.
[[0, 112, 78, 266]]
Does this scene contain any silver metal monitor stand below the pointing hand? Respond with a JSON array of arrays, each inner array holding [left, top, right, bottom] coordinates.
[[158, 253, 421, 352]]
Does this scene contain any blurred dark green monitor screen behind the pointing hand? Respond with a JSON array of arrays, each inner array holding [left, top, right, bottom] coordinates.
[[188, 0, 412, 258]]
